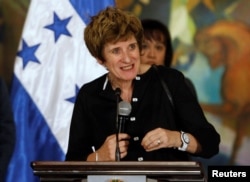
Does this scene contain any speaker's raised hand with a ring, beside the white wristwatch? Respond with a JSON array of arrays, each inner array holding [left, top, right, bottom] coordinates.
[[141, 128, 180, 152]]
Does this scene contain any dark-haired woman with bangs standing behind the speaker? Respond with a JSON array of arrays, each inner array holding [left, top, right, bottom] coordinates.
[[141, 19, 197, 97]]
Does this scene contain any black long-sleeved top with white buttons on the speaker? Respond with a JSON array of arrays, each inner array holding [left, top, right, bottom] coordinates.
[[66, 66, 220, 161]]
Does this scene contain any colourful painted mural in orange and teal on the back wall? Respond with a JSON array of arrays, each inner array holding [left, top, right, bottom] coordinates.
[[117, 0, 250, 165]]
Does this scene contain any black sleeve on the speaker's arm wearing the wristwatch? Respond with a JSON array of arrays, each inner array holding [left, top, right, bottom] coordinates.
[[159, 66, 220, 158]]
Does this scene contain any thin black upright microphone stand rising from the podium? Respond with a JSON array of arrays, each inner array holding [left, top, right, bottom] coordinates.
[[115, 88, 121, 161]]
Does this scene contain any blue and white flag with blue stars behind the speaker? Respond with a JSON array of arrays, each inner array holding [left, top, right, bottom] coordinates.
[[6, 0, 115, 182]]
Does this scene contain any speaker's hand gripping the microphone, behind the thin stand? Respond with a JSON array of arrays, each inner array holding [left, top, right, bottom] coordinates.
[[97, 133, 130, 161]]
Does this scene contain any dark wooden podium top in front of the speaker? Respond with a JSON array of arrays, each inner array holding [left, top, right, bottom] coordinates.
[[31, 161, 206, 182]]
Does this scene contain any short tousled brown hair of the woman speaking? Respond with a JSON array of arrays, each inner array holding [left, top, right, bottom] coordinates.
[[84, 7, 143, 61]]
